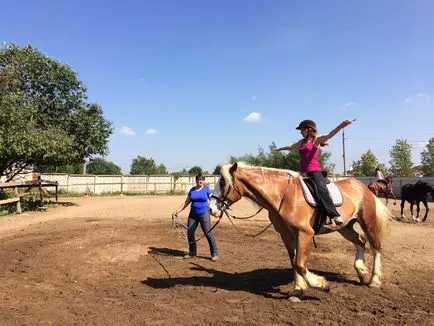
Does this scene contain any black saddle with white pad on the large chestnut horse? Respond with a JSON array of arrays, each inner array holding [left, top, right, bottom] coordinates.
[[298, 172, 343, 234]]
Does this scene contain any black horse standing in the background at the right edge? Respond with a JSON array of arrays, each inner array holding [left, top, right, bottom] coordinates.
[[401, 181, 434, 222]]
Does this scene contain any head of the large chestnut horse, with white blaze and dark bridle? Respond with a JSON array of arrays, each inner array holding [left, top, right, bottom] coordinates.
[[209, 163, 243, 216]]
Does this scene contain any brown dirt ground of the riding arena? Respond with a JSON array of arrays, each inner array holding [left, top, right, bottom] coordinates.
[[0, 196, 434, 325]]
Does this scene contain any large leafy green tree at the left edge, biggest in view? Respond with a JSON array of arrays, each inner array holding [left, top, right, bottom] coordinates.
[[0, 44, 113, 179]]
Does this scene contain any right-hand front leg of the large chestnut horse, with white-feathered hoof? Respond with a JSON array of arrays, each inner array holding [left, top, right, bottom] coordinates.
[[296, 227, 330, 292]]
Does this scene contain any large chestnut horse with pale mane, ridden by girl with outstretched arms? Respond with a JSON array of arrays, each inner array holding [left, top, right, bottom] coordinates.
[[210, 163, 390, 301]]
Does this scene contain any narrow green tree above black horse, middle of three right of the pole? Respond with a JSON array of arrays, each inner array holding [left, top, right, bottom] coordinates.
[[389, 139, 413, 177]]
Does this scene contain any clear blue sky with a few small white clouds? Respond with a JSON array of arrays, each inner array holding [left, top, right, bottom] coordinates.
[[0, 0, 434, 173]]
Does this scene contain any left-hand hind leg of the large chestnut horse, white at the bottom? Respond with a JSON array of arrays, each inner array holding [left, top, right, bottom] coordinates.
[[339, 223, 371, 285]]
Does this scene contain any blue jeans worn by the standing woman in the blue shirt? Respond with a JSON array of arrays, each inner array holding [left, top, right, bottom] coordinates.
[[187, 212, 218, 256]]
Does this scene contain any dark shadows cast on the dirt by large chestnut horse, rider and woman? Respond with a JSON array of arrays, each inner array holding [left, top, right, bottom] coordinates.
[[140, 248, 359, 300]]
